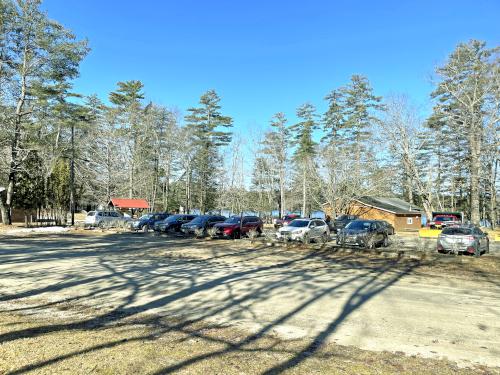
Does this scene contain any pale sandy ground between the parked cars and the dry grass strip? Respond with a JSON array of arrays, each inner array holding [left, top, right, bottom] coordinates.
[[0, 233, 500, 370]]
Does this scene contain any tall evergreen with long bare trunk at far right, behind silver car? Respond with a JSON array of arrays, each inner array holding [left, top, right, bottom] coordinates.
[[432, 40, 498, 224]]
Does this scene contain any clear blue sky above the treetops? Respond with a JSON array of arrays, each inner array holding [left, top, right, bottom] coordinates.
[[43, 0, 500, 133]]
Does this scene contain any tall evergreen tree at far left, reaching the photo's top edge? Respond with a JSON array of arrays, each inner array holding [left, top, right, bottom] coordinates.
[[0, 0, 88, 223]]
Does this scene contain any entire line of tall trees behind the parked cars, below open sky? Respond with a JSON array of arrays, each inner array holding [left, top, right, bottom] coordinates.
[[0, 0, 500, 223]]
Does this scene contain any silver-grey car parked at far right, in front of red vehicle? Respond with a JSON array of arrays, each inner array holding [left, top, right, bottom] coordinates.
[[437, 224, 490, 257]]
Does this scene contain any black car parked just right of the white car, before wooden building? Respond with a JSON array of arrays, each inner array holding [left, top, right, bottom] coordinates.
[[337, 220, 389, 249]]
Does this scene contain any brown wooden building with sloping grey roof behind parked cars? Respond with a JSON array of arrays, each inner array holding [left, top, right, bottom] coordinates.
[[324, 197, 422, 232]]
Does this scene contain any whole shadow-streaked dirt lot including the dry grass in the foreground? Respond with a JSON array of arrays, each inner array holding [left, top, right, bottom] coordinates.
[[0, 232, 500, 374]]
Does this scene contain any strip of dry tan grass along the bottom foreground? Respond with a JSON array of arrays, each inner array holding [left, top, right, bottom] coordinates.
[[0, 313, 500, 374]]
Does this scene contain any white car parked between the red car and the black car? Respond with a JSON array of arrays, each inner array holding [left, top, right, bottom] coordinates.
[[276, 219, 330, 243]]
